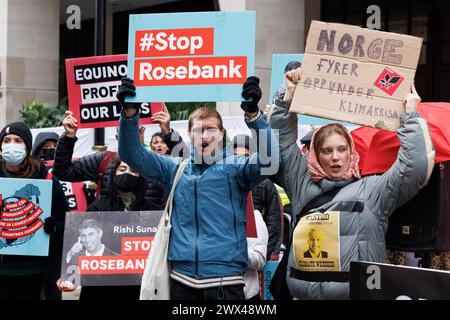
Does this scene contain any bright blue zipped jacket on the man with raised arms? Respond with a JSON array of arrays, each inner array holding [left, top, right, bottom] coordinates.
[[119, 112, 279, 279]]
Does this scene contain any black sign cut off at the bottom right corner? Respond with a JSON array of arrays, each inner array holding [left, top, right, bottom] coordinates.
[[350, 261, 450, 300]]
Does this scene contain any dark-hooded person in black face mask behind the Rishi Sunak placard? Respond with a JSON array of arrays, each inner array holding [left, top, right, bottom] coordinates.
[[56, 157, 154, 300]]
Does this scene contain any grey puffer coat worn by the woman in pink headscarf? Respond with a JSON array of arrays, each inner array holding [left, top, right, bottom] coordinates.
[[270, 100, 434, 299]]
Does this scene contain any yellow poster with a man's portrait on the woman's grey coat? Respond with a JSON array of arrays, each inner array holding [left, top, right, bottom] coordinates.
[[294, 211, 341, 271]]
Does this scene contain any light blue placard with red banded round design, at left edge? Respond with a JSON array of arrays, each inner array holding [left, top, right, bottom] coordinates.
[[0, 178, 52, 256]]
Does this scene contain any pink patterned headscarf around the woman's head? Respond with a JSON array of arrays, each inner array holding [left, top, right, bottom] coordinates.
[[307, 123, 361, 182]]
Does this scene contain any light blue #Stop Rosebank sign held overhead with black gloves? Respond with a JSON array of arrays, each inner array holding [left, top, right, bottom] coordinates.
[[126, 11, 255, 102]]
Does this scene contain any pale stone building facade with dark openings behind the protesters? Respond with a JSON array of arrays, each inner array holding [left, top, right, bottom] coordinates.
[[0, 0, 450, 127]]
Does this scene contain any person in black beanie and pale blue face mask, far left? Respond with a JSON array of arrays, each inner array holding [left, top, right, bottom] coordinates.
[[0, 122, 68, 300]]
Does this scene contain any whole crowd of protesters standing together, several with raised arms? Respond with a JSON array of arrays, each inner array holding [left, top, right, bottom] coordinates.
[[0, 56, 434, 300]]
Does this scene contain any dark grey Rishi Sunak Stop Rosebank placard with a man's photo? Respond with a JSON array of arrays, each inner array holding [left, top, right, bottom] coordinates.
[[61, 211, 162, 286]]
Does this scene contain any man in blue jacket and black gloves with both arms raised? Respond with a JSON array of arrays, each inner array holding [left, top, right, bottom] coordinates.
[[118, 77, 279, 300]]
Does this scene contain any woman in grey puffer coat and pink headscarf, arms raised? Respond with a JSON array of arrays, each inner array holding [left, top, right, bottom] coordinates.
[[270, 69, 434, 299]]
